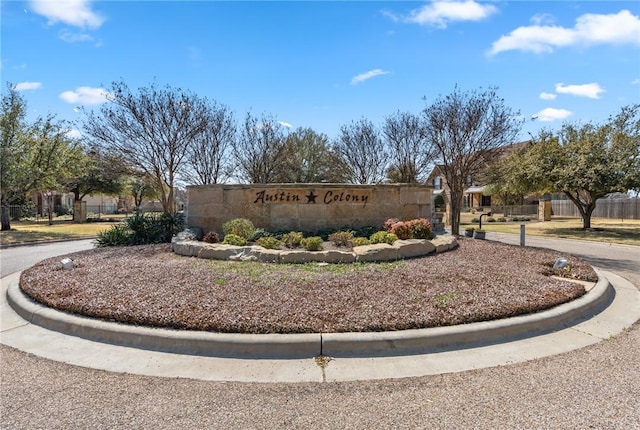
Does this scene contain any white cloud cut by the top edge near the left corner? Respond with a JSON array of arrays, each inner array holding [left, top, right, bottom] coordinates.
[[29, 0, 104, 29]]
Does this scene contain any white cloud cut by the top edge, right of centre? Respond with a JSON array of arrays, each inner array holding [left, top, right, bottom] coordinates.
[[396, 0, 498, 28]]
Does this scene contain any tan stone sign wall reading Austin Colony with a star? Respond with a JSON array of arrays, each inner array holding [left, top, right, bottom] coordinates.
[[186, 184, 433, 232]]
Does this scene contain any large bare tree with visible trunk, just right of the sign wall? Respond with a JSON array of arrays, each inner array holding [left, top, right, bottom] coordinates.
[[423, 86, 523, 234]]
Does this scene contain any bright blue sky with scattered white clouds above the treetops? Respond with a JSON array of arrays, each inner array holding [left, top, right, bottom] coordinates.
[[0, 0, 640, 139]]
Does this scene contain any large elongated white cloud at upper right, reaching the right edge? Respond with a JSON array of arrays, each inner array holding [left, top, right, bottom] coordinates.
[[489, 10, 640, 55]]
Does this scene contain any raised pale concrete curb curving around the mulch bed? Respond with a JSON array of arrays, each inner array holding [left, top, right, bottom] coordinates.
[[7, 270, 615, 359]]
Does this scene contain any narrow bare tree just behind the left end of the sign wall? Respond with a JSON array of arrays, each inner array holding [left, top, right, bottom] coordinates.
[[185, 102, 236, 185]]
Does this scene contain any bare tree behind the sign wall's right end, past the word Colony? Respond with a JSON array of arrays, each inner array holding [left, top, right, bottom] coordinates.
[[382, 111, 435, 183]]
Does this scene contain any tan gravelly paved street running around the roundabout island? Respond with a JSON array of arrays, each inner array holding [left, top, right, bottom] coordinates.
[[0, 237, 640, 429]]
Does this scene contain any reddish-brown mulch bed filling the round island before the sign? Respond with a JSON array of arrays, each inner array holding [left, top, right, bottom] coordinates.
[[20, 238, 597, 333]]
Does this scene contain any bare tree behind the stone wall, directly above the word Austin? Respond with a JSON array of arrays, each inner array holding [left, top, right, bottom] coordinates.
[[232, 113, 286, 184]]
